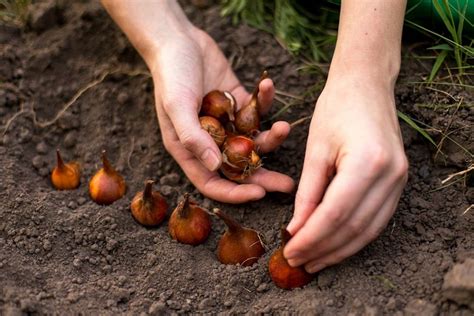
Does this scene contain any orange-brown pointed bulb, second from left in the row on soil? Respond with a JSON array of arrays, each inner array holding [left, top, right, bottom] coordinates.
[[89, 150, 126, 205]]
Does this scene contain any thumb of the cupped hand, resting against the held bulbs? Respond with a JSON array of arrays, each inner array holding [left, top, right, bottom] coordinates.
[[163, 97, 221, 171]]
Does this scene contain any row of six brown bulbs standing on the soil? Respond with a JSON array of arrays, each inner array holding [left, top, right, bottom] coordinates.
[[51, 150, 313, 289]]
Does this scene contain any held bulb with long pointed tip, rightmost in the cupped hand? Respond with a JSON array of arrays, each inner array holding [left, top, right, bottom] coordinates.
[[234, 70, 268, 135]]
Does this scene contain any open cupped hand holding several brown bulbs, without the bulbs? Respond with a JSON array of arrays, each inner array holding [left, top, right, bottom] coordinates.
[[147, 28, 294, 203]]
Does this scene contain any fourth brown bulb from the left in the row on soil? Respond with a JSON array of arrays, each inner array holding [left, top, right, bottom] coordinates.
[[168, 193, 211, 246]]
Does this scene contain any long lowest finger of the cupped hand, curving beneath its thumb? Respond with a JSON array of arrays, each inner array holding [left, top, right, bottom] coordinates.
[[157, 107, 265, 203]]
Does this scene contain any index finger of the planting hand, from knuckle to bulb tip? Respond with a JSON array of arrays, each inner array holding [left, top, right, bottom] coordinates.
[[284, 159, 379, 265]]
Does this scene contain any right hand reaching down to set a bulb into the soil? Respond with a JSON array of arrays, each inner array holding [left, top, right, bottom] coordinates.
[[284, 76, 408, 273]]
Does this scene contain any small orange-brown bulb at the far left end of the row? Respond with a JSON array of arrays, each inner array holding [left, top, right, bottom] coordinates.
[[51, 149, 81, 190]]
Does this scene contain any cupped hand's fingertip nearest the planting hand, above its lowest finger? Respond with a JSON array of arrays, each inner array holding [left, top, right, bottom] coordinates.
[[244, 168, 295, 193]]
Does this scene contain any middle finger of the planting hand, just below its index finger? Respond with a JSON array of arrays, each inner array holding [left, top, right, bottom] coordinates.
[[296, 175, 403, 262]]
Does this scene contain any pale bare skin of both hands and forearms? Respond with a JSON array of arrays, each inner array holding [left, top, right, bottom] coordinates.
[[102, 0, 408, 272]]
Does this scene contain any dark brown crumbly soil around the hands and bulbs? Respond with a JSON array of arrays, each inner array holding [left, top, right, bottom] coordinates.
[[0, 1, 474, 315]]
